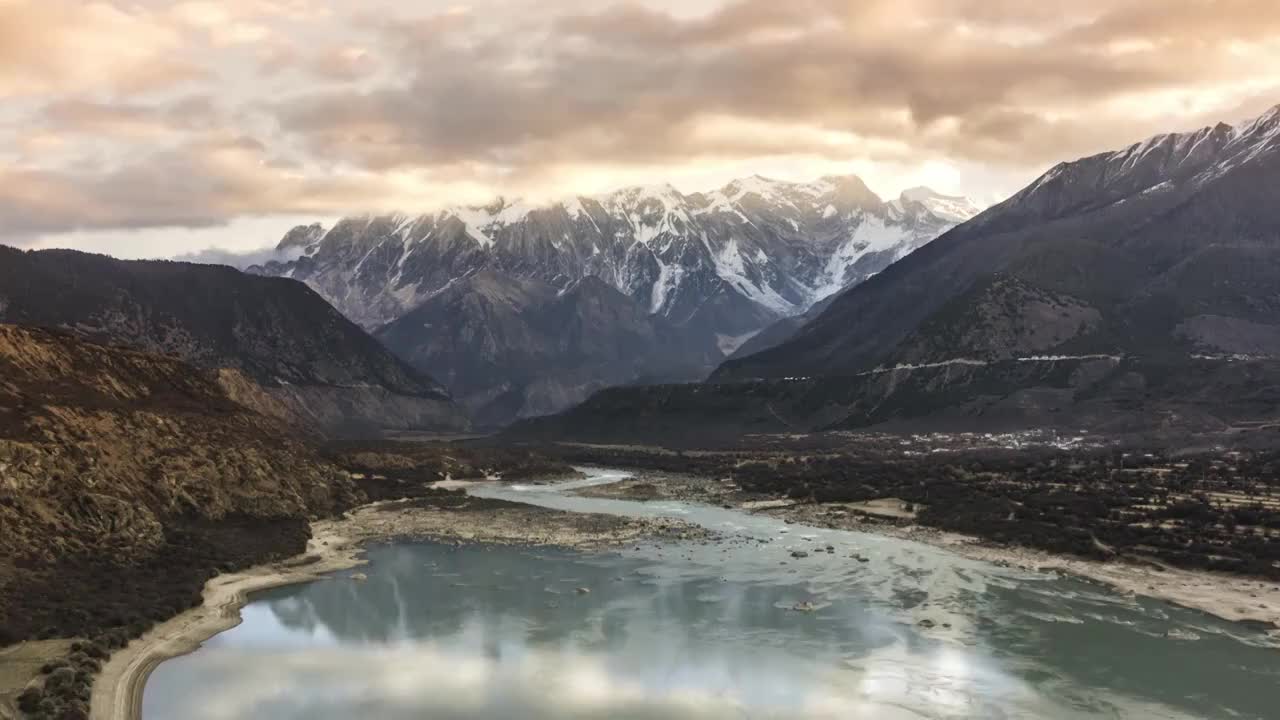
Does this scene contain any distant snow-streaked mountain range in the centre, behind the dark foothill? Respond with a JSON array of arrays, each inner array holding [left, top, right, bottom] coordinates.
[[251, 176, 978, 420]]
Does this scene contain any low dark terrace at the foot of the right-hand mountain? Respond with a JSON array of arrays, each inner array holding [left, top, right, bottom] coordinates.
[[504, 357, 1280, 447]]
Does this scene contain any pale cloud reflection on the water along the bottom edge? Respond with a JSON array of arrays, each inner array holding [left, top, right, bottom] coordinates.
[[160, 633, 1061, 720]]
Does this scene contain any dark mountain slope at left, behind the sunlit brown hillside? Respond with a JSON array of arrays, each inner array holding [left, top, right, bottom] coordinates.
[[0, 247, 466, 430]]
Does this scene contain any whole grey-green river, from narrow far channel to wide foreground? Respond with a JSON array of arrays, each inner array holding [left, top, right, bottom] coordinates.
[[143, 470, 1280, 720]]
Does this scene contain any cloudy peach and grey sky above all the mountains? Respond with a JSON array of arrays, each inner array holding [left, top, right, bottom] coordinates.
[[0, 0, 1280, 258]]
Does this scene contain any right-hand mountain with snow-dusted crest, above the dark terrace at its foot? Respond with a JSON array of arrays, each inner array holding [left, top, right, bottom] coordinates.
[[717, 106, 1280, 381]]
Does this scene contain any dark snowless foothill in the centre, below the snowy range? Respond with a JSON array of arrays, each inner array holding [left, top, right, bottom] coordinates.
[[376, 270, 719, 424]]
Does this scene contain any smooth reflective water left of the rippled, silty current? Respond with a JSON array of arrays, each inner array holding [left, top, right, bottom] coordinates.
[[145, 538, 1228, 720]]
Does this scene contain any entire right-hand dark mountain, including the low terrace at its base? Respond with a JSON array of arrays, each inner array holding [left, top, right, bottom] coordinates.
[[513, 108, 1280, 442]]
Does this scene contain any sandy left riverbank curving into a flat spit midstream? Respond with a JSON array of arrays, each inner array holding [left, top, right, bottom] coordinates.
[[90, 492, 709, 720]]
